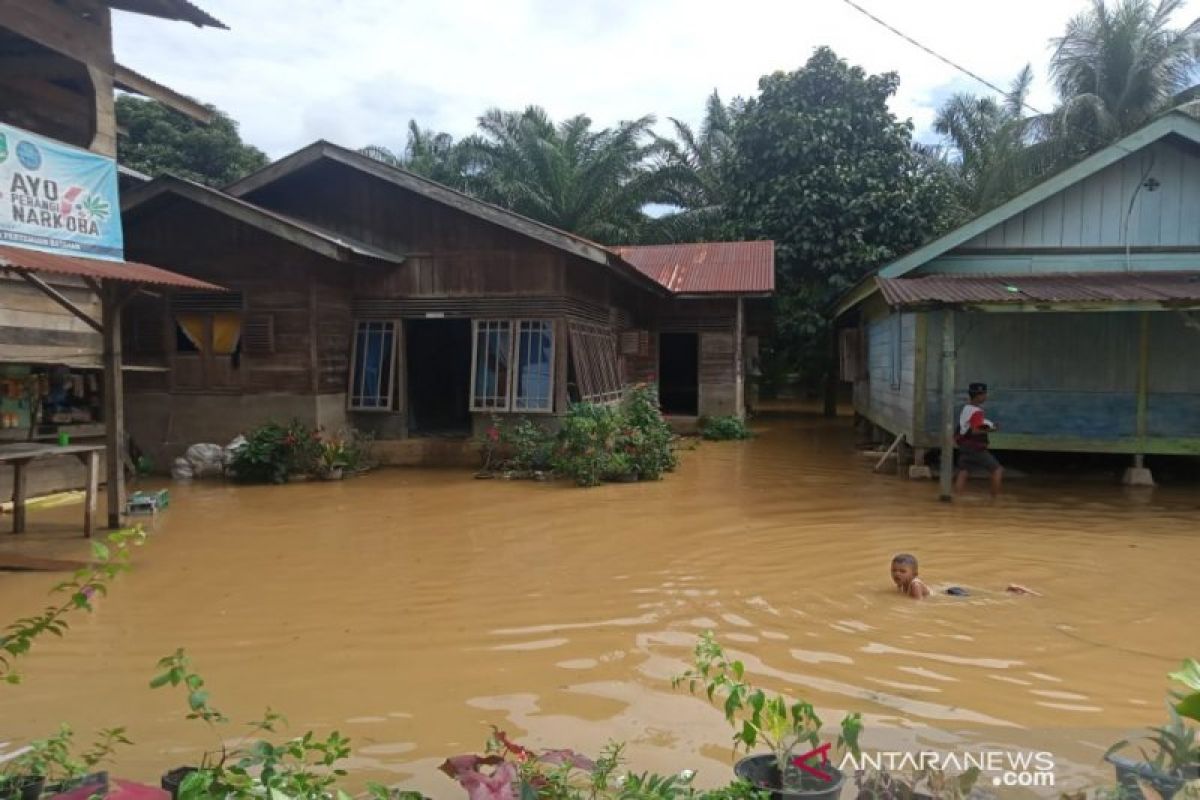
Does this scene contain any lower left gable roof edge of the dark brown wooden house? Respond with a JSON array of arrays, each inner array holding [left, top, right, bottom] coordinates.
[[121, 174, 404, 264]]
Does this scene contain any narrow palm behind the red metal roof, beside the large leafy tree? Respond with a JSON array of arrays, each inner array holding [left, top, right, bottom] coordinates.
[[653, 90, 740, 241]]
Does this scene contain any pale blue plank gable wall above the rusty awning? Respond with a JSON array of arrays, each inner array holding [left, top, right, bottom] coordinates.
[[959, 140, 1200, 251]]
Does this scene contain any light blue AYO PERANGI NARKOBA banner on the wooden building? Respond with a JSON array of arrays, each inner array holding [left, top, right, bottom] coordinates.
[[0, 122, 125, 261]]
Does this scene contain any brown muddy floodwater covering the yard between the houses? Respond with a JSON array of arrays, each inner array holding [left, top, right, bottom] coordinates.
[[0, 416, 1200, 796]]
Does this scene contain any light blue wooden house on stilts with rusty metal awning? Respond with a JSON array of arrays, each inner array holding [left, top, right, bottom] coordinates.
[[836, 113, 1200, 495]]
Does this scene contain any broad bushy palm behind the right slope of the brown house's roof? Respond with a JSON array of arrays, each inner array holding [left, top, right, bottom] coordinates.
[[462, 106, 661, 245]]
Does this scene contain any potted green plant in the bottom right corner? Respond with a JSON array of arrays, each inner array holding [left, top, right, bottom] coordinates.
[[1104, 658, 1200, 800]]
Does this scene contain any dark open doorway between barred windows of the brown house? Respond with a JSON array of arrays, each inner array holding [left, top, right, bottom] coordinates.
[[404, 319, 470, 437]]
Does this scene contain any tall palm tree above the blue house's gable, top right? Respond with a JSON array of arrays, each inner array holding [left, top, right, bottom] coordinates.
[[1050, 0, 1200, 157]]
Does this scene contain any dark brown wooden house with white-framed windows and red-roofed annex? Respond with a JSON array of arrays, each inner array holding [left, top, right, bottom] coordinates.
[[124, 142, 774, 463]]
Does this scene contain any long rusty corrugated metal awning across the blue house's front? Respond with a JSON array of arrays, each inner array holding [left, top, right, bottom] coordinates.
[[876, 271, 1200, 306]]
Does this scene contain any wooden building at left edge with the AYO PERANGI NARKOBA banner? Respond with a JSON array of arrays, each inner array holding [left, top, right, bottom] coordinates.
[[0, 0, 223, 519]]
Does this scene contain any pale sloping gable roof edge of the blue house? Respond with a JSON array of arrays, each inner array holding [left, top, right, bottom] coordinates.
[[834, 112, 1200, 315]]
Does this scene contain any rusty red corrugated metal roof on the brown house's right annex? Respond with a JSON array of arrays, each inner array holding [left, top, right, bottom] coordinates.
[[612, 241, 775, 294]]
